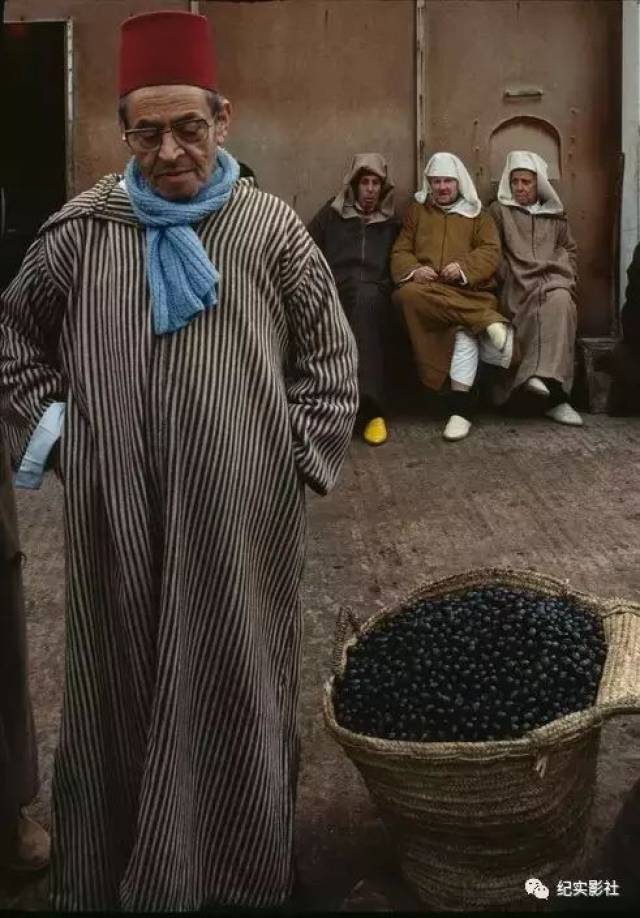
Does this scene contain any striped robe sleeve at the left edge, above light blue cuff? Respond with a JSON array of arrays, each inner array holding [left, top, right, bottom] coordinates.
[[0, 227, 67, 469]]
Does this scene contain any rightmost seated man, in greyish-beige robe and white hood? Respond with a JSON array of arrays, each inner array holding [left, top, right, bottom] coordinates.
[[490, 150, 582, 426]]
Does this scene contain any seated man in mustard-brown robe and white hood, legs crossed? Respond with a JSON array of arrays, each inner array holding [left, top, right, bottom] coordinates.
[[391, 153, 513, 440]]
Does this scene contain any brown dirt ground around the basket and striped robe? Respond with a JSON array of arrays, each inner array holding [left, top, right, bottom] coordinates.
[[0, 413, 640, 911]]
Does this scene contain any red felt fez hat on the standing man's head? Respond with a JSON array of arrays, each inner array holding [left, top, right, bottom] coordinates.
[[120, 10, 217, 96]]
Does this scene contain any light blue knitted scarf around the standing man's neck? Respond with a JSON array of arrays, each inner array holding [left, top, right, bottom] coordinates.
[[125, 149, 240, 335]]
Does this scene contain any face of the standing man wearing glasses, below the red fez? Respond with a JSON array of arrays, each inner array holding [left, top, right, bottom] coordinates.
[[122, 86, 230, 201]]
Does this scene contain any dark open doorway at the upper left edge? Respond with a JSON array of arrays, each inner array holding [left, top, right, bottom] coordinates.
[[0, 22, 66, 290]]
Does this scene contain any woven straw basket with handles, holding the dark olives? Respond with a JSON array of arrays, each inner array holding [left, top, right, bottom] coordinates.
[[324, 568, 640, 910]]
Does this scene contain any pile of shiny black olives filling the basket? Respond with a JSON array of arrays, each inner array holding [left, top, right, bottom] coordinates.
[[334, 586, 607, 742]]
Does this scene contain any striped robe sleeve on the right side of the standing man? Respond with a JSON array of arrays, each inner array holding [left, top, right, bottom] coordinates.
[[285, 226, 358, 494]]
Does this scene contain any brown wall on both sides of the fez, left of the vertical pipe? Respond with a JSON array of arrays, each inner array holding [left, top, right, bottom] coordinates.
[[5, 0, 415, 219]]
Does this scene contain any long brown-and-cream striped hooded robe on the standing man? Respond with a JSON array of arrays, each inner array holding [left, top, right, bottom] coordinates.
[[0, 176, 357, 910]]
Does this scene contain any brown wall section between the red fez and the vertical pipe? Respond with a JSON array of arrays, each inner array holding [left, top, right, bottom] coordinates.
[[199, 0, 415, 219]]
